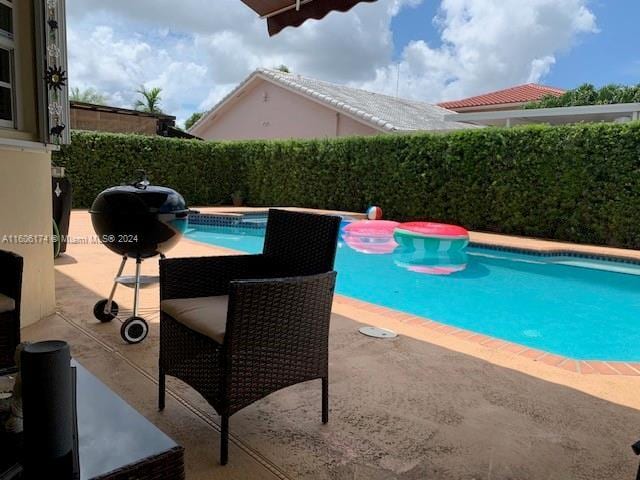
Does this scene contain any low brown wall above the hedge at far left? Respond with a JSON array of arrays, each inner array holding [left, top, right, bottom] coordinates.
[[71, 107, 158, 135]]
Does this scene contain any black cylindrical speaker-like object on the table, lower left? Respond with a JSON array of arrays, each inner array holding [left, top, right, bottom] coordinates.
[[20, 340, 74, 479]]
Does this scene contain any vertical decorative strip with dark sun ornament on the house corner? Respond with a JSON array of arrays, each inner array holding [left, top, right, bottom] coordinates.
[[34, 0, 70, 145]]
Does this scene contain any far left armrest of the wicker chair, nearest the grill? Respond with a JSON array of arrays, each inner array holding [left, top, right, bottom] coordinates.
[[160, 255, 264, 300]]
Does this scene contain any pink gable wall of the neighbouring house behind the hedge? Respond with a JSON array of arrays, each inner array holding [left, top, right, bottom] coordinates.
[[192, 80, 379, 140]]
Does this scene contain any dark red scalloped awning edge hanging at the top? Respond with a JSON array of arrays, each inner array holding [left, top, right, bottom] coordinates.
[[242, 0, 376, 36]]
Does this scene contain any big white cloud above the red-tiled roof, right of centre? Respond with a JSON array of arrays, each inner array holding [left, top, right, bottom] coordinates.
[[363, 0, 597, 101]]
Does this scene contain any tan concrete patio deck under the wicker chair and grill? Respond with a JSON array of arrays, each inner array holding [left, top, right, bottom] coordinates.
[[23, 211, 640, 480]]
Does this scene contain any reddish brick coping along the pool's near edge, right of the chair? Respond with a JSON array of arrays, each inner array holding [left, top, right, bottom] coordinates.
[[334, 294, 640, 376]]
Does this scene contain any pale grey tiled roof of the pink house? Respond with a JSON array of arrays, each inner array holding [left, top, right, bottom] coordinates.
[[192, 68, 477, 132]]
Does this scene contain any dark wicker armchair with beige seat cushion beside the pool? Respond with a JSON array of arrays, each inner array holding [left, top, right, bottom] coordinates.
[[158, 210, 340, 465]]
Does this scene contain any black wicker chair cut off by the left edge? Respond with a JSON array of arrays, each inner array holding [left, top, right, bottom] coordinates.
[[0, 250, 23, 371]]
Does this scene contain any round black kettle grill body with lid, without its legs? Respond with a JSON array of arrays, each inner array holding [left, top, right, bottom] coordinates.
[[90, 174, 189, 258]]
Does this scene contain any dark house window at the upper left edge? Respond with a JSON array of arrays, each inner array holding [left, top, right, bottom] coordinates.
[[0, 0, 16, 128]]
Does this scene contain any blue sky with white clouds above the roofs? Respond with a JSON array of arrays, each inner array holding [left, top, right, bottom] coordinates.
[[67, 0, 640, 123]]
